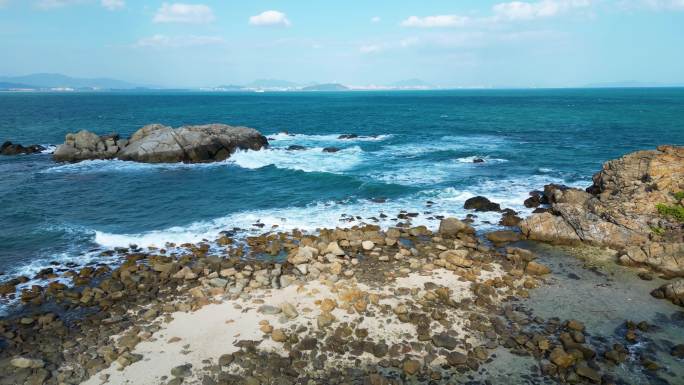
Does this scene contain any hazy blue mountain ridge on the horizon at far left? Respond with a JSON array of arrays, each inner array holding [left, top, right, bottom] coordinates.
[[0, 73, 140, 89]]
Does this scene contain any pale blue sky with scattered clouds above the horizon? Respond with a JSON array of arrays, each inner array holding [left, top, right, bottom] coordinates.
[[0, 0, 684, 87]]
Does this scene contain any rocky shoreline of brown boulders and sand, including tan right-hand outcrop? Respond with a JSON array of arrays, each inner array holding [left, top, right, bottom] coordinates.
[[0, 145, 684, 385]]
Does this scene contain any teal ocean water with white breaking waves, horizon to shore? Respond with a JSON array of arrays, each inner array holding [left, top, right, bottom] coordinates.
[[0, 89, 684, 306]]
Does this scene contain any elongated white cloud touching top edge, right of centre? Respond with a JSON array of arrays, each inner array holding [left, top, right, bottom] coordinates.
[[493, 0, 591, 20]]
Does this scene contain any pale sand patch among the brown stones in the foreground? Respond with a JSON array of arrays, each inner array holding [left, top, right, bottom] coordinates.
[[85, 269, 498, 385]]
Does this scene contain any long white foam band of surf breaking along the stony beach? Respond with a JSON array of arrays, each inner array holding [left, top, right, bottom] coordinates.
[[88, 176, 588, 248]]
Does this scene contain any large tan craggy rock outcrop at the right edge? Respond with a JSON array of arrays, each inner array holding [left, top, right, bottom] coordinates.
[[520, 146, 684, 275]]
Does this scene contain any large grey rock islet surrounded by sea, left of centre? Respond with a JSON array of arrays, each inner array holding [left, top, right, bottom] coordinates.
[[53, 124, 268, 163]]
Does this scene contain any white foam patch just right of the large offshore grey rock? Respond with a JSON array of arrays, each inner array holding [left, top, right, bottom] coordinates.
[[228, 146, 363, 173]]
